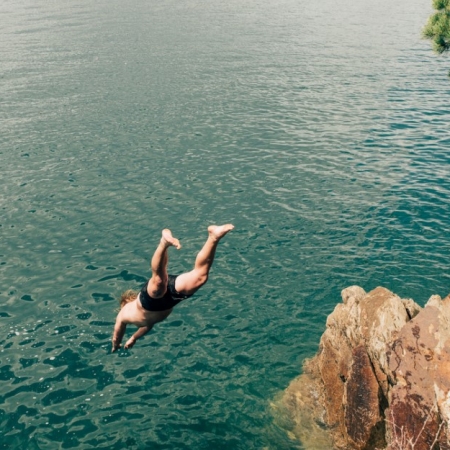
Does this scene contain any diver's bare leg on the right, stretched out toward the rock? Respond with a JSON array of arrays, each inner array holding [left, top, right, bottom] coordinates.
[[175, 223, 234, 295]]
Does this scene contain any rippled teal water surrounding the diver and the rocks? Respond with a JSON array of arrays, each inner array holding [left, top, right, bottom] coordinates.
[[0, 0, 450, 449]]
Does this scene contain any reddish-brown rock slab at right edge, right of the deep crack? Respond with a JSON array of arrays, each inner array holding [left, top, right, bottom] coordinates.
[[387, 296, 450, 450]]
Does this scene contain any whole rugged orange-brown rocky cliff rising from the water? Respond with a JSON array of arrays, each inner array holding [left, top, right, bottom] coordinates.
[[281, 286, 450, 450]]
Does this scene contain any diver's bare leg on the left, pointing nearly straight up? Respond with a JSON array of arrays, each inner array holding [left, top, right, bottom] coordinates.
[[147, 229, 181, 298]]
